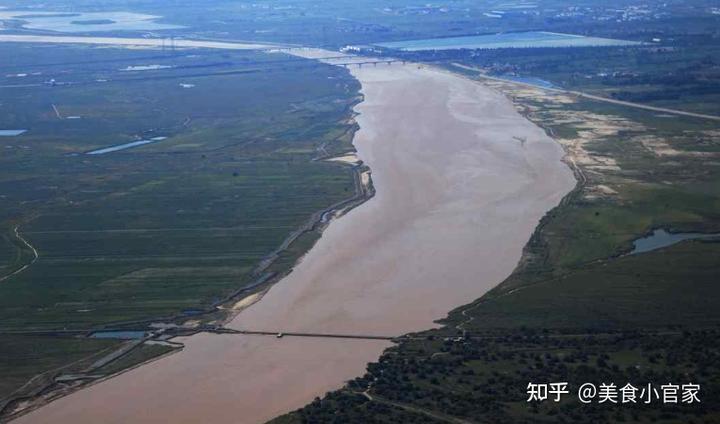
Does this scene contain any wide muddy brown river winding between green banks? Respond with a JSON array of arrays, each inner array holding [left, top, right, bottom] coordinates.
[[18, 61, 575, 423]]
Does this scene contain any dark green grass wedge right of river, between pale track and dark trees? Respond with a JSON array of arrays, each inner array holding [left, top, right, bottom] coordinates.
[[462, 241, 720, 329]]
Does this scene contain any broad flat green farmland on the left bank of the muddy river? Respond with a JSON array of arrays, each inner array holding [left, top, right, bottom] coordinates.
[[0, 44, 359, 398]]
